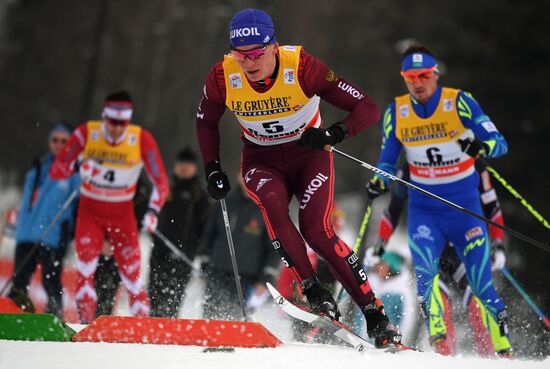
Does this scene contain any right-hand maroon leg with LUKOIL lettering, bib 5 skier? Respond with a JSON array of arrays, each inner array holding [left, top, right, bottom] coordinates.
[[289, 150, 401, 346]]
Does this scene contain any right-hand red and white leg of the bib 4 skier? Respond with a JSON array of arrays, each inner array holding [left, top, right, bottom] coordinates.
[[108, 208, 150, 316]]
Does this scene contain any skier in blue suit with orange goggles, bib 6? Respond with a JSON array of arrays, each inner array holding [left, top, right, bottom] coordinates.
[[367, 46, 512, 356]]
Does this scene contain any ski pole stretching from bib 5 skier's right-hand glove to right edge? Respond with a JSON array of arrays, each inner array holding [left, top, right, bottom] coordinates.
[[325, 145, 550, 252]]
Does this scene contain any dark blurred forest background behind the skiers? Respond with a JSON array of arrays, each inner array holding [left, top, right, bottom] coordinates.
[[0, 0, 550, 354]]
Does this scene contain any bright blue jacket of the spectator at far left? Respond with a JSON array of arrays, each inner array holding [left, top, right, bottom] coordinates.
[[15, 154, 80, 249]]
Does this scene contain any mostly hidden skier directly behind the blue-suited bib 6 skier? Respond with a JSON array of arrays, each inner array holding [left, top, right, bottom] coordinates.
[[374, 161, 506, 356]]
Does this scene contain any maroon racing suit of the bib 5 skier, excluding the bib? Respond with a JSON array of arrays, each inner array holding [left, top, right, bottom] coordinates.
[[196, 49, 380, 308]]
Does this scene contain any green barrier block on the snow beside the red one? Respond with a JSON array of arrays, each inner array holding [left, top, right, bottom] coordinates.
[[0, 314, 76, 341]]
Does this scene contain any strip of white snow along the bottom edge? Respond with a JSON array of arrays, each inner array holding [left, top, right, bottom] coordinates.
[[0, 341, 550, 369]]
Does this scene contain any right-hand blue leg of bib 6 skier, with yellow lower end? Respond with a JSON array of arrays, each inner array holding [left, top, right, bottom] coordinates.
[[447, 208, 511, 355]]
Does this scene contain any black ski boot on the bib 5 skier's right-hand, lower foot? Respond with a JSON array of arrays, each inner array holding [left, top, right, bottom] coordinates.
[[363, 303, 401, 348]]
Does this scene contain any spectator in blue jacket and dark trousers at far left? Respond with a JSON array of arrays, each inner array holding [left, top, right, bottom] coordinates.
[[9, 123, 80, 317]]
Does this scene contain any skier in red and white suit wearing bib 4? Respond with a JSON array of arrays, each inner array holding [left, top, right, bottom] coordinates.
[[50, 91, 169, 323]]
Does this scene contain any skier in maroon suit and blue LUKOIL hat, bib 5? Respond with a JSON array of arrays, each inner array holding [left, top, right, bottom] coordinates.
[[197, 9, 400, 346]]
